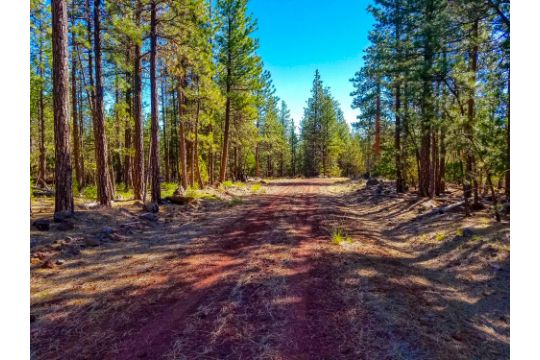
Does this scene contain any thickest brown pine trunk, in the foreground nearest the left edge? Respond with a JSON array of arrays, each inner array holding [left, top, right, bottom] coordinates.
[[51, 0, 74, 214]]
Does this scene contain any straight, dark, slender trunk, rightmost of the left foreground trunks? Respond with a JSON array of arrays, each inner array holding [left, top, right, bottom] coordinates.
[[150, 0, 161, 204]]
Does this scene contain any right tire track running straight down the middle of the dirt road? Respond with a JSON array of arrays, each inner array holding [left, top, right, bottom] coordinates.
[[276, 181, 348, 359]]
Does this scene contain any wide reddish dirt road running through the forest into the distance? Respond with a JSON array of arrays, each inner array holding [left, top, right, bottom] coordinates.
[[32, 179, 508, 360]]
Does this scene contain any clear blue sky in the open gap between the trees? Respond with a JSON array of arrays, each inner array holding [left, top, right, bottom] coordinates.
[[249, 0, 373, 125]]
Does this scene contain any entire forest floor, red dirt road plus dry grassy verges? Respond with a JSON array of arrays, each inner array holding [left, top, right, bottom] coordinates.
[[30, 179, 510, 360]]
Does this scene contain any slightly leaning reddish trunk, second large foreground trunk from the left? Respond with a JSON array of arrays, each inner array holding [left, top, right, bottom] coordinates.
[[94, 0, 113, 207]]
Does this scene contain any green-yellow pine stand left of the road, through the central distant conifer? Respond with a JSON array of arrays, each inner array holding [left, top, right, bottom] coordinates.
[[30, 1, 363, 212]]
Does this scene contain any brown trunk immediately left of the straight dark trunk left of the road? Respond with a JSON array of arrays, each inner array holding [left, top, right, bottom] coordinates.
[[133, 0, 144, 200]]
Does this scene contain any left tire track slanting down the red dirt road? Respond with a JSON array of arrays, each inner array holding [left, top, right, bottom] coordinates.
[[110, 186, 298, 360]]
